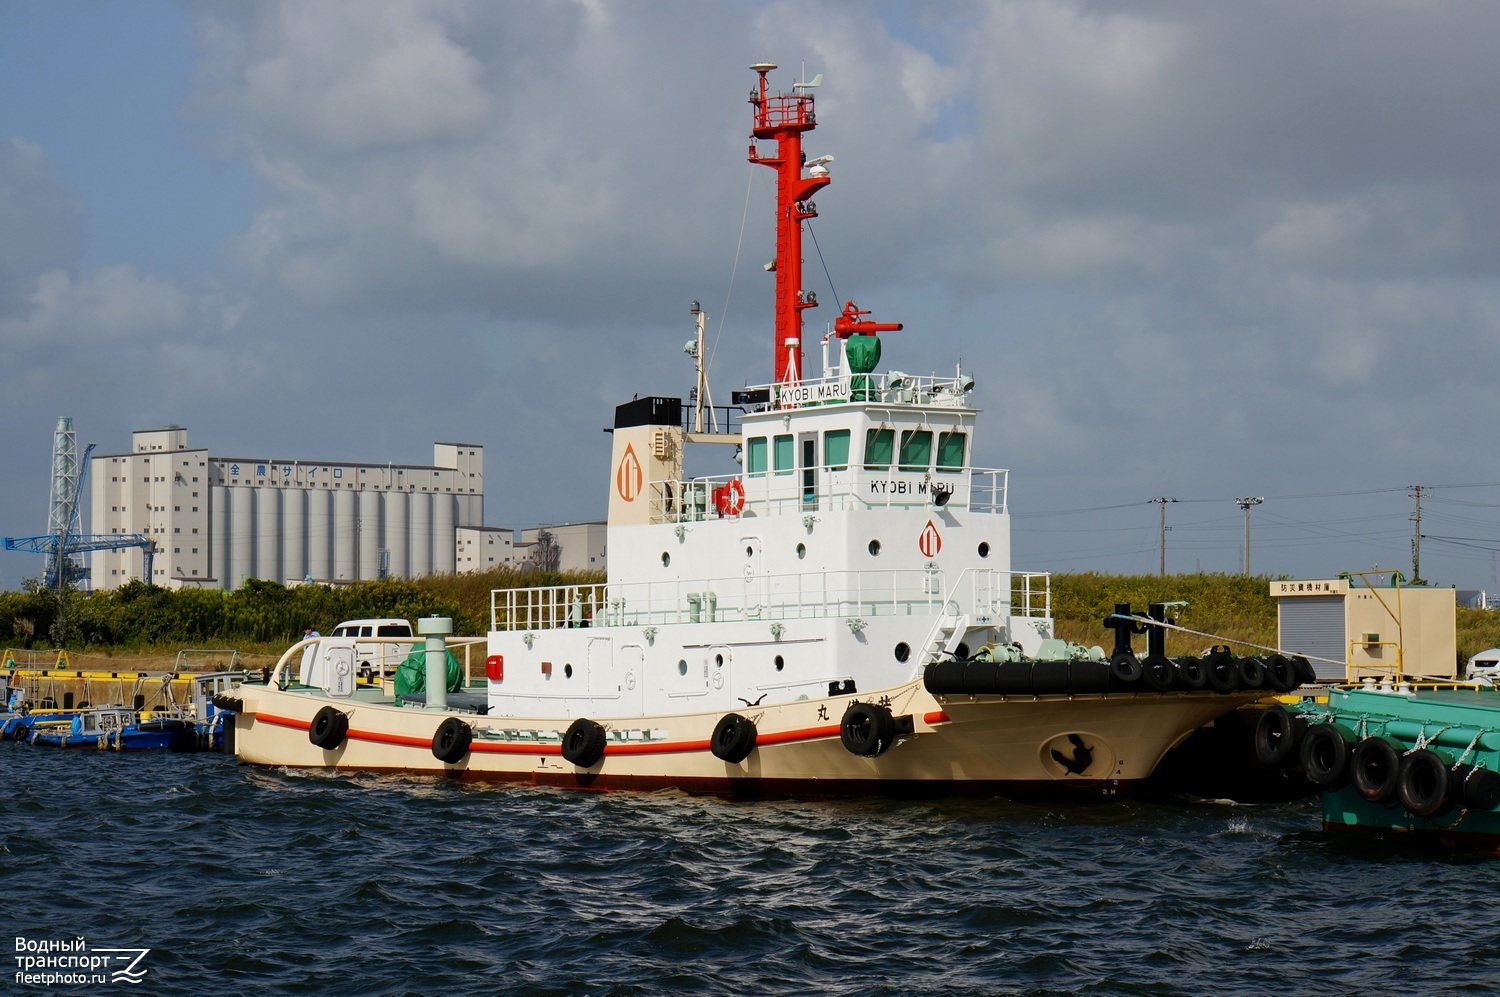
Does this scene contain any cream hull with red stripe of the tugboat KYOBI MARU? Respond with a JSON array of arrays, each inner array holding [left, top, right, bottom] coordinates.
[[234, 682, 1262, 798]]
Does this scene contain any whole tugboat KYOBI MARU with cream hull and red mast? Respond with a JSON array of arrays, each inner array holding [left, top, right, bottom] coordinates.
[[224, 63, 1298, 798]]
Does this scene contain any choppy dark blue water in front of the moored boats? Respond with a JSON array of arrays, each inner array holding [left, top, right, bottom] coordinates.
[[0, 742, 1500, 996]]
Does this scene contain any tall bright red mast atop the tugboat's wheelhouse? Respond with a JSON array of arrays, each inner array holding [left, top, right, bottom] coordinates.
[[750, 63, 830, 384]]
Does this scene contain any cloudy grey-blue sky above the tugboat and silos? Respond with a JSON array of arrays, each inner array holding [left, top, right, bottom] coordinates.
[[0, 0, 1500, 589]]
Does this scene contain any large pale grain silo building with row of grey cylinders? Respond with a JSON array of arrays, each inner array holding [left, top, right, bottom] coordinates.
[[90, 426, 486, 589]]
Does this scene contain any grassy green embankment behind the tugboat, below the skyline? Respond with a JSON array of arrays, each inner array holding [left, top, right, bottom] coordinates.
[[0, 570, 1500, 667]]
